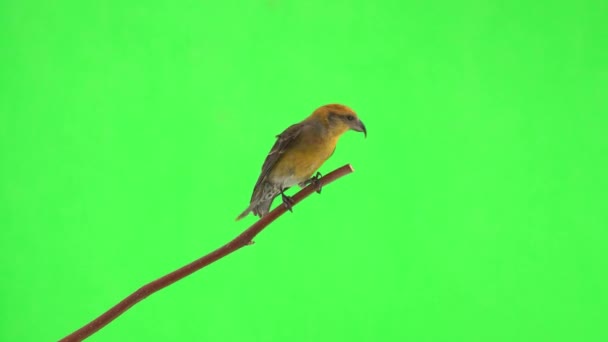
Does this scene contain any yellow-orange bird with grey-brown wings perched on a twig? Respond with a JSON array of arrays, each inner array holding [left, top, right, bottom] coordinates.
[[236, 104, 367, 221]]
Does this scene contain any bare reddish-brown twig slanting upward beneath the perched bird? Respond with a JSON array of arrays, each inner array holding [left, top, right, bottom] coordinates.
[[61, 164, 354, 342]]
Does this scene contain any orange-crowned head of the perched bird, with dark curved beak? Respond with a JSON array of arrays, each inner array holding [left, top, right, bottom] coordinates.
[[310, 104, 367, 137]]
